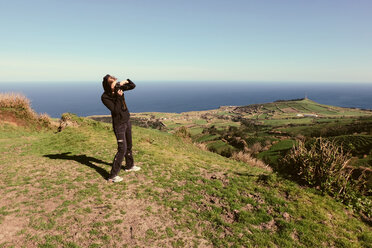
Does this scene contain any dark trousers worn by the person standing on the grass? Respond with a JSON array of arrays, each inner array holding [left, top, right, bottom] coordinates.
[[109, 120, 134, 178]]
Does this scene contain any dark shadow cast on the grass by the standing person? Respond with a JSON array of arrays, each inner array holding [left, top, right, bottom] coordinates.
[[43, 152, 111, 179]]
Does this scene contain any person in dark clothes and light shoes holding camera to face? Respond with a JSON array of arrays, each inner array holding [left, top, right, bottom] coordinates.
[[101, 74, 141, 183]]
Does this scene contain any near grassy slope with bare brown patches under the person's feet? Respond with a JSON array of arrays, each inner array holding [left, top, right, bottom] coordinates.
[[0, 120, 372, 247]]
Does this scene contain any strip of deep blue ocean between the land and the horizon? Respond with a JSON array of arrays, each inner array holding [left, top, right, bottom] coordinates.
[[0, 81, 372, 117]]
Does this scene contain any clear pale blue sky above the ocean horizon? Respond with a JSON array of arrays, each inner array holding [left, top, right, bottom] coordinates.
[[0, 0, 372, 83]]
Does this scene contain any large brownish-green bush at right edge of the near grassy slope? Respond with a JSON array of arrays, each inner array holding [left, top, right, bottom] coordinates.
[[279, 138, 372, 218]]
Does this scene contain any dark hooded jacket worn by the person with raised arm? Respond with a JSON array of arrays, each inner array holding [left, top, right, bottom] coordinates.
[[101, 81, 136, 126]]
